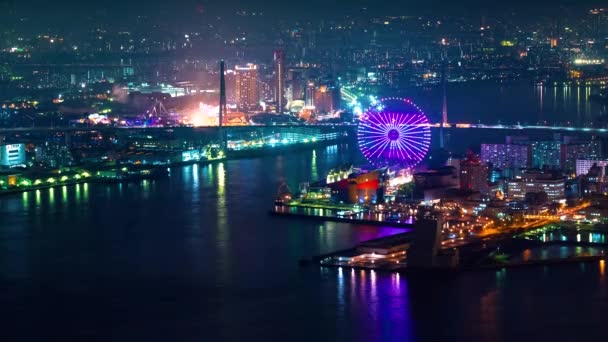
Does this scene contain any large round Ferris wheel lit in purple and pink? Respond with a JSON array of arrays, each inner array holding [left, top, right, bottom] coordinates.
[[357, 98, 431, 167]]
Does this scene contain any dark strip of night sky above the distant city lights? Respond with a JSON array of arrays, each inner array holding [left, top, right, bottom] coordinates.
[[7, 0, 605, 16]]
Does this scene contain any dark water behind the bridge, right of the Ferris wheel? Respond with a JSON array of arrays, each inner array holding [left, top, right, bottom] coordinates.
[[410, 81, 606, 126]]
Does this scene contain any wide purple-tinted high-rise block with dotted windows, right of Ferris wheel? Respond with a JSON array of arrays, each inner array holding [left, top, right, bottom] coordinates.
[[481, 144, 530, 169]]
